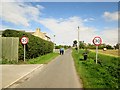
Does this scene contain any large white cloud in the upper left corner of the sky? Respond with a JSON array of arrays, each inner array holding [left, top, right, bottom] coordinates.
[[0, 2, 43, 26]]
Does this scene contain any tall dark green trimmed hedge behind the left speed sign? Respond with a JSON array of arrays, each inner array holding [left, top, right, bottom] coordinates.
[[2, 29, 54, 60]]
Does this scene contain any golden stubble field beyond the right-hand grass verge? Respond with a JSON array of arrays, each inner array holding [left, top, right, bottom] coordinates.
[[90, 50, 120, 57]]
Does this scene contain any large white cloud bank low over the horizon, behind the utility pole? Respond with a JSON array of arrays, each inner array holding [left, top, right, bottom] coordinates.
[[39, 17, 118, 45]]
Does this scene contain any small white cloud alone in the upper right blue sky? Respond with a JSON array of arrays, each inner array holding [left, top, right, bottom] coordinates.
[[103, 11, 118, 21]]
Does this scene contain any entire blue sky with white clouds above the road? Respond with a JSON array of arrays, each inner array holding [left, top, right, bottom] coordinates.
[[0, 0, 119, 46]]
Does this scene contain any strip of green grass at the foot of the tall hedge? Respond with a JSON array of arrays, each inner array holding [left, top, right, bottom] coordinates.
[[0, 53, 59, 64]]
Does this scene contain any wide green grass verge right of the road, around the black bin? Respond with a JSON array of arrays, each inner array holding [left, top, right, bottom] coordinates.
[[72, 50, 120, 88]]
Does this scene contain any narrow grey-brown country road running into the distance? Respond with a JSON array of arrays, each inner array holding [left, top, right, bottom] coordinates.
[[11, 49, 82, 88]]
